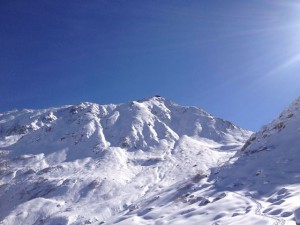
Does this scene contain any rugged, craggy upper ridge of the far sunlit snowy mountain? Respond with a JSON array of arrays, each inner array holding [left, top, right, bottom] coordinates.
[[0, 97, 250, 160]]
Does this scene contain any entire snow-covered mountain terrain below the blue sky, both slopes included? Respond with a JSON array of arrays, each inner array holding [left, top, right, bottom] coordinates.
[[0, 97, 300, 225]]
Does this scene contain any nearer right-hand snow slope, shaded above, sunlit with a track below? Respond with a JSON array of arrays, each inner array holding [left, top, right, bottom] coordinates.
[[106, 98, 300, 225]]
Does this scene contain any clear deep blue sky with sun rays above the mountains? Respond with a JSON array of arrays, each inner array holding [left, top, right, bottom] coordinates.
[[0, 0, 300, 130]]
